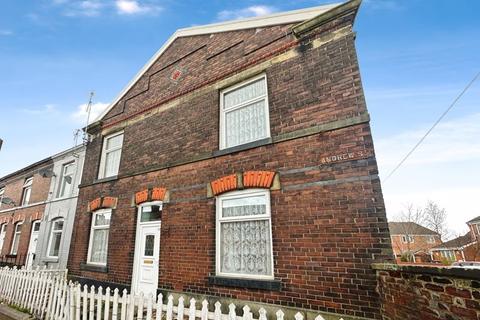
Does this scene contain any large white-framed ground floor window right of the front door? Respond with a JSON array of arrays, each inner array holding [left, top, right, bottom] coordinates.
[[216, 189, 273, 279]]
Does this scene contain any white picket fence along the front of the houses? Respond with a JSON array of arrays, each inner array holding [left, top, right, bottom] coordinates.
[[0, 268, 343, 320]]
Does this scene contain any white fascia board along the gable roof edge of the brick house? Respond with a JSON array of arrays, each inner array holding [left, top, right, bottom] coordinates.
[[93, 3, 341, 123]]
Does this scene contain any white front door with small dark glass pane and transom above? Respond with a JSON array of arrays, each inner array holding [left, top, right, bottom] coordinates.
[[132, 203, 162, 297]]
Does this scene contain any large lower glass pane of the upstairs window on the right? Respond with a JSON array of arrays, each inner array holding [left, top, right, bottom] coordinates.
[[225, 100, 267, 147]]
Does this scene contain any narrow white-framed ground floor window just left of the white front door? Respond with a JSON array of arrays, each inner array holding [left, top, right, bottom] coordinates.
[[87, 209, 112, 265]]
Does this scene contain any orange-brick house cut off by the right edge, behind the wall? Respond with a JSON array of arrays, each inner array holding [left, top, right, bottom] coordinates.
[[430, 216, 480, 263]]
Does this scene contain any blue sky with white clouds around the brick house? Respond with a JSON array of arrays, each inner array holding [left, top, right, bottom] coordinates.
[[0, 0, 480, 235]]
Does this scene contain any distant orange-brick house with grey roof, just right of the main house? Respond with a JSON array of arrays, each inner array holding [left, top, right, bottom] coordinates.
[[388, 222, 442, 263]]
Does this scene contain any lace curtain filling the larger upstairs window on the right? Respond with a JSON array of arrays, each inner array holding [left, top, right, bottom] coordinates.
[[223, 78, 267, 147]]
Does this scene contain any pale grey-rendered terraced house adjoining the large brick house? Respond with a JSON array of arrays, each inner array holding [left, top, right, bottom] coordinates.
[[34, 145, 85, 269]]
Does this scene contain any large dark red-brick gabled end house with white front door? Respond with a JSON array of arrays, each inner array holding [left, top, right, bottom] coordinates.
[[68, 1, 392, 319]]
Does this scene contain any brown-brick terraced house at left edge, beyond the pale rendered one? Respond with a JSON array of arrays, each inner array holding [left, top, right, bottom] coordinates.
[[0, 158, 52, 267]]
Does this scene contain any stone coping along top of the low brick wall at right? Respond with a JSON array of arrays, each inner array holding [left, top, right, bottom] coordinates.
[[372, 263, 480, 280]]
